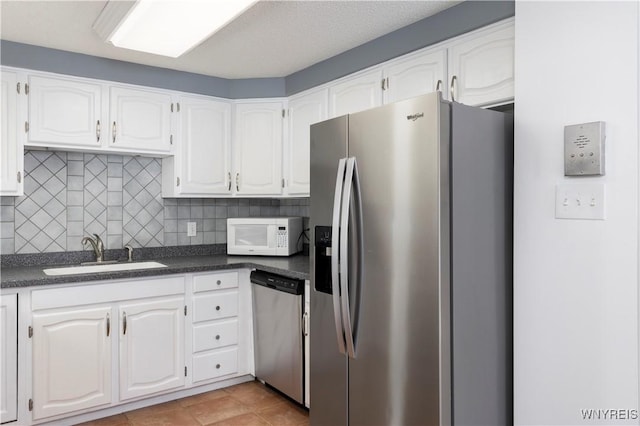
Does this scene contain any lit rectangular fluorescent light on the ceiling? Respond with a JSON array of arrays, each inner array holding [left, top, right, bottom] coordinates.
[[108, 0, 257, 58]]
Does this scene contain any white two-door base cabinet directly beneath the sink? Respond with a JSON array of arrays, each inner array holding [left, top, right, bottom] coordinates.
[[31, 276, 185, 421]]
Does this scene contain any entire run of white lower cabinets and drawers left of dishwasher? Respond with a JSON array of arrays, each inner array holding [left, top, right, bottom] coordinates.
[[0, 269, 254, 425]]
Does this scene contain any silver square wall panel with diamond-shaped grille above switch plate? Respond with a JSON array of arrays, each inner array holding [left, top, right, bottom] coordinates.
[[564, 121, 605, 176]]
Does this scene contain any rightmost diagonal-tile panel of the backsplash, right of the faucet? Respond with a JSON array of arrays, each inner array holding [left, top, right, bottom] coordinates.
[[122, 157, 164, 247]]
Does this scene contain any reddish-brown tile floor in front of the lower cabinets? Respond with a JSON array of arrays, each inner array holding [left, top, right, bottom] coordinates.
[[82, 381, 309, 426]]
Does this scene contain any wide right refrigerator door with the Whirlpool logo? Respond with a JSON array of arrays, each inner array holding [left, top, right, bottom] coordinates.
[[344, 93, 451, 426]]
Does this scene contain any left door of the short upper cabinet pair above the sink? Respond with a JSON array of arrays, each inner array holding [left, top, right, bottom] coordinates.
[[27, 76, 102, 149]]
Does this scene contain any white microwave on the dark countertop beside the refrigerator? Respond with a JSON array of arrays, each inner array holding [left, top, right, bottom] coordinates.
[[227, 217, 303, 256]]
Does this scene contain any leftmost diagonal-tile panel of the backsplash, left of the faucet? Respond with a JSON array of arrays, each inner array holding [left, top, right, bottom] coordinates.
[[14, 151, 67, 253]]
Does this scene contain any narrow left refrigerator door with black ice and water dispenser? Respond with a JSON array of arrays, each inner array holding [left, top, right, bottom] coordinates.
[[309, 116, 348, 426]]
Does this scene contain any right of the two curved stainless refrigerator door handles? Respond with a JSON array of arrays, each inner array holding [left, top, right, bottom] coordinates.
[[339, 157, 363, 358]]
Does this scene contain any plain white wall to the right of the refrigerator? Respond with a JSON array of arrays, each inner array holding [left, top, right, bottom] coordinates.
[[514, 1, 640, 425]]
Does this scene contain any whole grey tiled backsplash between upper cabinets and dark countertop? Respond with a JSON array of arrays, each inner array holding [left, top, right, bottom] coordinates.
[[0, 151, 309, 254]]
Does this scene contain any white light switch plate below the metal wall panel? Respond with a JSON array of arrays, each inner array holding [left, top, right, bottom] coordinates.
[[556, 183, 605, 220]]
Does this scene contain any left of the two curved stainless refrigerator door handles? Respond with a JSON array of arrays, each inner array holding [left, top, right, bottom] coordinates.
[[331, 158, 347, 354]]
